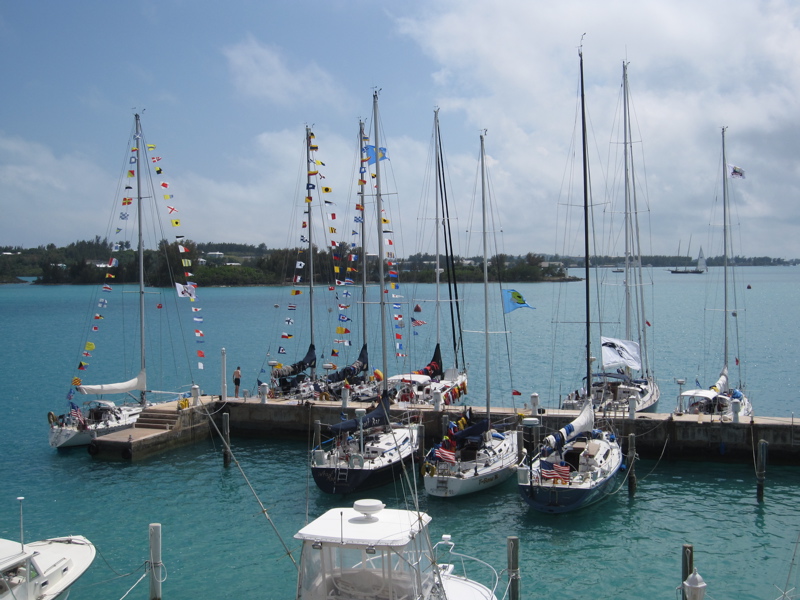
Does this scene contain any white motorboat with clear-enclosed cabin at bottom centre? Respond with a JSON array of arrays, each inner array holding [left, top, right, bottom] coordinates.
[[294, 499, 498, 600]]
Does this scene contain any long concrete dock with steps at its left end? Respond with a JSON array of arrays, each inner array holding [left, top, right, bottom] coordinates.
[[89, 396, 800, 465]]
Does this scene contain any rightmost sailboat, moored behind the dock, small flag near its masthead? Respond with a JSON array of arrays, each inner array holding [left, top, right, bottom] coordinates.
[[679, 127, 753, 421]]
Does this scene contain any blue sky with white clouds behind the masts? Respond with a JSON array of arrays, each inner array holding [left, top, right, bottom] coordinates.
[[0, 0, 800, 259]]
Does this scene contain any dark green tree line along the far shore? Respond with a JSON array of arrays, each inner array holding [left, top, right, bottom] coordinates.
[[0, 236, 797, 287]]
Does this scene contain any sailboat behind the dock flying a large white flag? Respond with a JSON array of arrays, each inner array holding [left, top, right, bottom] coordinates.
[[562, 62, 661, 412]]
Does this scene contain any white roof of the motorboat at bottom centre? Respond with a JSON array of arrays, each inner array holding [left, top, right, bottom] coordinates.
[[294, 500, 431, 547]]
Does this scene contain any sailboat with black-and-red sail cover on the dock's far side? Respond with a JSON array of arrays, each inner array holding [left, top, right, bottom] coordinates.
[[389, 108, 468, 404]]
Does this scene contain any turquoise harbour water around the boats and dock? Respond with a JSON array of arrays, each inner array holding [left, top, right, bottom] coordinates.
[[0, 268, 800, 599]]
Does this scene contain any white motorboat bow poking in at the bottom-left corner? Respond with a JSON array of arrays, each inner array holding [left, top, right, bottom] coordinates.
[[0, 535, 95, 600]]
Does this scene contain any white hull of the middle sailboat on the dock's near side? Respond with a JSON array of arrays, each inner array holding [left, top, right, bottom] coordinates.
[[423, 431, 519, 498]]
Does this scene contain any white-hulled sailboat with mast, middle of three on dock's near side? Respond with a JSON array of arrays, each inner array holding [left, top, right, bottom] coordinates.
[[423, 134, 522, 498]]
